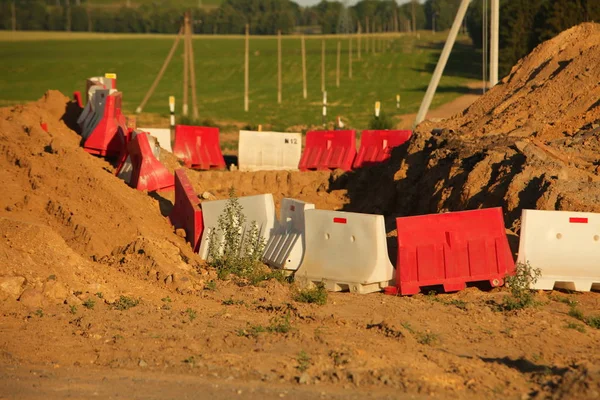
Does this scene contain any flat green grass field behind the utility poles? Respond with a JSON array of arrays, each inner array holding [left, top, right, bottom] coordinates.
[[0, 32, 481, 129]]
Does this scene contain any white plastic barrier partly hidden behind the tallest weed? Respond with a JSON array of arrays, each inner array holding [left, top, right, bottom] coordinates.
[[198, 193, 276, 260]]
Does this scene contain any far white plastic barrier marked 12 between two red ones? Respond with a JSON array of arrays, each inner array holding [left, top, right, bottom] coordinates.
[[238, 131, 302, 171]]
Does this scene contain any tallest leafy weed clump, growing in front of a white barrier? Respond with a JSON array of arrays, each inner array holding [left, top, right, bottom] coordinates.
[[208, 188, 265, 280]]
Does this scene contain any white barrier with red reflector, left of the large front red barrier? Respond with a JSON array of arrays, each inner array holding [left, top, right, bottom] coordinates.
[[296, 210, 395, 293]]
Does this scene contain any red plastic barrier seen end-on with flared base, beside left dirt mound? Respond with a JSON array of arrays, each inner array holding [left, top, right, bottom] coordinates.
[[127, 132, 175, 192]]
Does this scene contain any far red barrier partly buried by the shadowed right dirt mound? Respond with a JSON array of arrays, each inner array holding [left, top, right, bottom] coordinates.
[[354, 130, 412, 168]]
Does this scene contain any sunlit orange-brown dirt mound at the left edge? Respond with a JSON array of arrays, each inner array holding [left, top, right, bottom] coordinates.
[[0, 91, 200, 304]]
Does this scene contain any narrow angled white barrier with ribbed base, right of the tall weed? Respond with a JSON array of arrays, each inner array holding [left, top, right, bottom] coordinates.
[[263, 199, 315, 271]]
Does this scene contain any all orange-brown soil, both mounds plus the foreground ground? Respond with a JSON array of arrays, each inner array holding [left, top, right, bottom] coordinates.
[[0, 24, 600, 399]]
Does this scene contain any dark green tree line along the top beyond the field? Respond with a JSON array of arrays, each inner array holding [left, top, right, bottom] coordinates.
[[0, 0, 600, 75]]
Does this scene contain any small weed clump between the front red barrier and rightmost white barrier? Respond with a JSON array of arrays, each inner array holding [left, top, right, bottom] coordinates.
[[500, 262, 541, 311]]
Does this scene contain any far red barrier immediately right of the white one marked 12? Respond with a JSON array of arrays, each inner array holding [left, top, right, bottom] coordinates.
[[298, 131, 356, 171]]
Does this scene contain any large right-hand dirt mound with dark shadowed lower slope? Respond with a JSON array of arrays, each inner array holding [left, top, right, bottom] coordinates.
[[340, 24, 600, 238]]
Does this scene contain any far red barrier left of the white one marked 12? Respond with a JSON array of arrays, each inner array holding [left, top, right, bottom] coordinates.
[[173, 125, 225, 169]]
